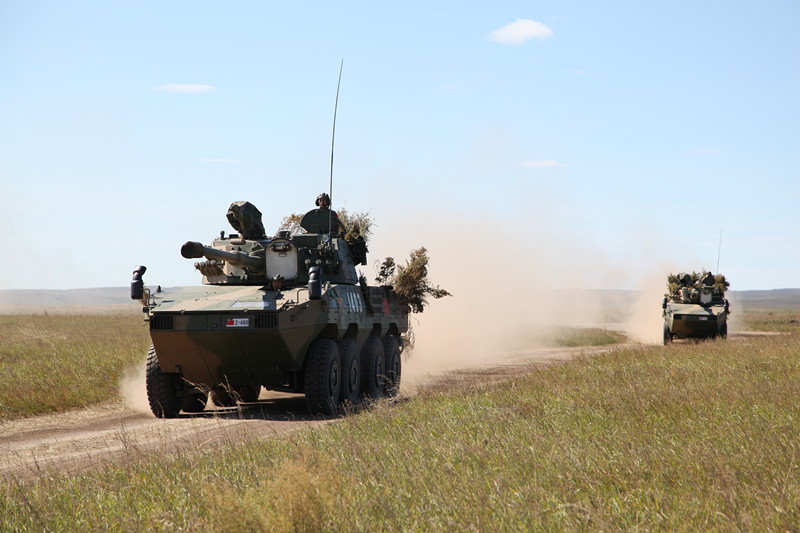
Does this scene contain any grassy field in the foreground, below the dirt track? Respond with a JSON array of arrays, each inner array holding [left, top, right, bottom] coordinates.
[[0, 314, 800, 531]]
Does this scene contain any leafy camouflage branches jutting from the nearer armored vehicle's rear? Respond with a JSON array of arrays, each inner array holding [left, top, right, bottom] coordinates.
[[375, 246, 452, 313]]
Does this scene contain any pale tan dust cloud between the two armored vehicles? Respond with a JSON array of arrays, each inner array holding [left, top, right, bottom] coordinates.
[[370, 209, 667, 383]]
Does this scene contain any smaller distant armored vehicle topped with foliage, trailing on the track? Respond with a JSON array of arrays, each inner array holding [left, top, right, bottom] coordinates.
[[662, 271, 730, 344]]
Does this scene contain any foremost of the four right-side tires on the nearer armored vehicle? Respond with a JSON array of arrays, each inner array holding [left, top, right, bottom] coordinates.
[[305, 338, 342, 416]]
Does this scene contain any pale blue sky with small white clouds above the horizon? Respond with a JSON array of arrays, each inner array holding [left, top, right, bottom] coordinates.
[[0, 0, 800, 294]]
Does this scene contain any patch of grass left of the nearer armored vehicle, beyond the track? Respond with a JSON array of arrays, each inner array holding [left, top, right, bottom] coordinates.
[[0, 314, 150, 420]]
